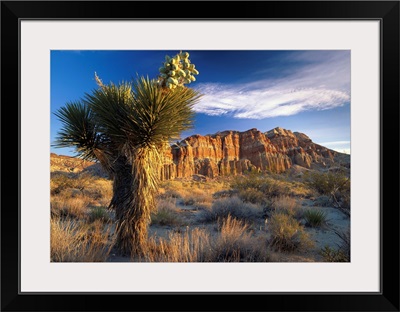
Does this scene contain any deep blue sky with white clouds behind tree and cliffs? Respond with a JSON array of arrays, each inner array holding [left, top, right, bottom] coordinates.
[[50, 50, 351, 156]]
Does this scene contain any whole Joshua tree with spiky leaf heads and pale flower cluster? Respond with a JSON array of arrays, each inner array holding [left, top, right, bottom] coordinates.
[[54, 52, 201, 256]]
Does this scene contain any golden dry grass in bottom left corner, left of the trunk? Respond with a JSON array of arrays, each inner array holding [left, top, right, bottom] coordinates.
[[50, 219, 114, 262]]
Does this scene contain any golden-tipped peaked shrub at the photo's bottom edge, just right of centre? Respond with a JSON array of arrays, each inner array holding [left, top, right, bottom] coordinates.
[[207, 215, 269, 262]]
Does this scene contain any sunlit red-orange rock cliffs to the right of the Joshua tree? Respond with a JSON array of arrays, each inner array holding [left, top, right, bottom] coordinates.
[[160, 127, 350, 180]]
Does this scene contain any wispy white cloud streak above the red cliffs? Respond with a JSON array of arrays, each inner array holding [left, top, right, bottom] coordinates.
[[194, 54, 350, 119]]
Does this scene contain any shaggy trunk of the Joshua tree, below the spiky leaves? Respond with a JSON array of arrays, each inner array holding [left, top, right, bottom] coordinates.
[[110, 147, 158, 257]]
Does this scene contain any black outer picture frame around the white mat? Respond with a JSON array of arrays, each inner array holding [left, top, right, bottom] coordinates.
[[0, 1, 400, 311]]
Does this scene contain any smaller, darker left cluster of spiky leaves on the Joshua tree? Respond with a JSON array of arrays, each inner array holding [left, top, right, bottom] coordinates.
[[53, 101, 102, 160]]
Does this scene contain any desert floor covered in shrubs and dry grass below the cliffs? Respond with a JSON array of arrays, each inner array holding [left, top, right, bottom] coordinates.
[[51, 172, 350, 262]]
